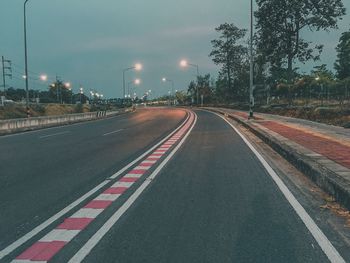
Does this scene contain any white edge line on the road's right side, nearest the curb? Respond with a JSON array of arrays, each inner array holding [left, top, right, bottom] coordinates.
[[211, 112, 345, 263]]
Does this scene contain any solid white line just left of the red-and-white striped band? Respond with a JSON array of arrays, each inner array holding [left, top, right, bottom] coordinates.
[[0, 111, 190, 260]]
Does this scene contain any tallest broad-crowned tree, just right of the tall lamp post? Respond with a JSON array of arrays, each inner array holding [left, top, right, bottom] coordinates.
[[255, 0, 345, 83]]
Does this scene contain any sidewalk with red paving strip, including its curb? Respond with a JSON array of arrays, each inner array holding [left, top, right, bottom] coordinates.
[[208, 108, 350, 209]]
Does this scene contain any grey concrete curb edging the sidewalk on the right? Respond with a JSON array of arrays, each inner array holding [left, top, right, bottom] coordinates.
[[207, 108, 350, 210]]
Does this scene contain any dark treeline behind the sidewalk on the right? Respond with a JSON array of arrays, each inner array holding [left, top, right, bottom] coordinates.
[[188, 0, 350, 108]]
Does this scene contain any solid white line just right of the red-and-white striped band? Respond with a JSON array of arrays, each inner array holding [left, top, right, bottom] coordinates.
[[68, 113, 197, 263]]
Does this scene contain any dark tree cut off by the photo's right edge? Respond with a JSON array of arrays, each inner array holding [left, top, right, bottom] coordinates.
[[334, 28, 350, 80]]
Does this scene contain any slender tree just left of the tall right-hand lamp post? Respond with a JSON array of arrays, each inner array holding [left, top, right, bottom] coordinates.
[[209, 23, 248, 96]]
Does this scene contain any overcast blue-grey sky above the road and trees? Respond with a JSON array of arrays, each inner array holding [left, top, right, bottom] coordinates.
[[0, 0, 350, 97]]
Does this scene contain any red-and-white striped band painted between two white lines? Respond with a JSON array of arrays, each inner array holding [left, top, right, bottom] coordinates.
[[12, 112, 195, 263]]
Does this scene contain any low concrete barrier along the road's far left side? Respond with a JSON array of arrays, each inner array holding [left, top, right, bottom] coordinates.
[[0, 109, 131, 135]]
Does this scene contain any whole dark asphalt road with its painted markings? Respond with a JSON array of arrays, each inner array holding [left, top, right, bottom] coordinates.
[[0, 108, 345, 263]]
